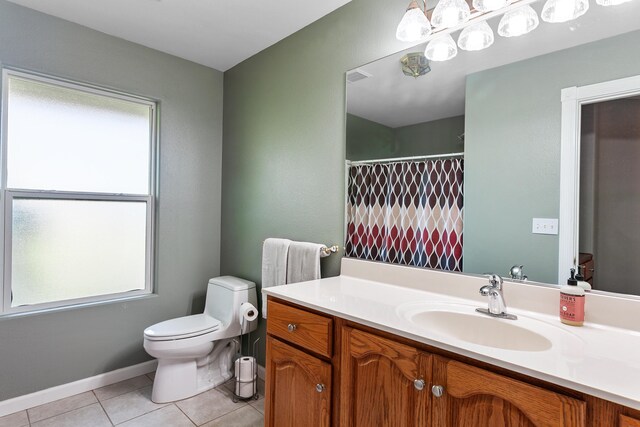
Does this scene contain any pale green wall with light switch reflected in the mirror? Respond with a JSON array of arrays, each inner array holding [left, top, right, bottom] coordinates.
[[464, 31, 640, 283]]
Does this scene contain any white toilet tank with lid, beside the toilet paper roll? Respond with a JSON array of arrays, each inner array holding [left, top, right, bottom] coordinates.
[[204, 276, 258, 328]]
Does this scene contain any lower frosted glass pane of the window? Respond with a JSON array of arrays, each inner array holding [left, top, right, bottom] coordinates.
[[11, 198, 147, 307]]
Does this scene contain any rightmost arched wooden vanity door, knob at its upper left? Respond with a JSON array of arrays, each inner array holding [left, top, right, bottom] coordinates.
[[432, 357, 585, 427]]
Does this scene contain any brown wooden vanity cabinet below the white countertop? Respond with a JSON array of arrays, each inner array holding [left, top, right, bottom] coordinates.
[[265, 299, 640, 427]]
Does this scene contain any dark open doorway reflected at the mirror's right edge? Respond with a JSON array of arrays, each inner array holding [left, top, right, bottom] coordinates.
[[579, 96, 640, 294]]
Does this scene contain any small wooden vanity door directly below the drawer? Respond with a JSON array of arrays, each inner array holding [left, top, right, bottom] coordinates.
[[265, 336, 331, 427]]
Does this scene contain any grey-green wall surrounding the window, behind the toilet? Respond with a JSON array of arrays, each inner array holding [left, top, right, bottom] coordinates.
[[0, 0, 223, 400]]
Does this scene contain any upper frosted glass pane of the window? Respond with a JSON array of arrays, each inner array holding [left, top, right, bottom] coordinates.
[[6, 75, 152, 194]]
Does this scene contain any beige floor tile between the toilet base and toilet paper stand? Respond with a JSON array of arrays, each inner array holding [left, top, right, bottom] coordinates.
[[176, 387, 247, 425]]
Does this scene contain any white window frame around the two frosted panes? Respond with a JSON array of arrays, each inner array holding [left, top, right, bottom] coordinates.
[[0, 66, 158, 316]]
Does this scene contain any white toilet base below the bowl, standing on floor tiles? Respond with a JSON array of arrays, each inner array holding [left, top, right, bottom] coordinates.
[[151, 339, 238, 403]]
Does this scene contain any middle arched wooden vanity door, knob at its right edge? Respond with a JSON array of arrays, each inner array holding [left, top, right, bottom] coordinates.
[[340, 327, 431, 427]]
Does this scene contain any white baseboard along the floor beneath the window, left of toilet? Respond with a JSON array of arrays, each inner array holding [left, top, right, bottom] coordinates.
[[0, 359, 158, 417]]
